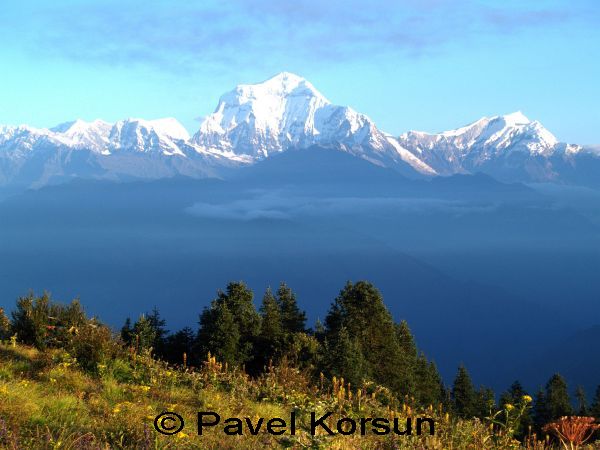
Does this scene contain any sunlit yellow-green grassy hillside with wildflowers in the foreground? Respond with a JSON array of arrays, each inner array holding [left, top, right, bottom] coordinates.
[[0, 342, 600, 449]]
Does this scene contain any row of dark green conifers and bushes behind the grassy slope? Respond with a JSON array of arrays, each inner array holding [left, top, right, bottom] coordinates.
[[0, 281, 600, 437]]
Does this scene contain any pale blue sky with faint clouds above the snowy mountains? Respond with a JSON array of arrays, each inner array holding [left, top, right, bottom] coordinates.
[[0, 0, 600, 144]]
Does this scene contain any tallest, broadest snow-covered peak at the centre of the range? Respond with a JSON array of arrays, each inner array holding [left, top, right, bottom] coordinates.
[[193, 72, 433, 174]]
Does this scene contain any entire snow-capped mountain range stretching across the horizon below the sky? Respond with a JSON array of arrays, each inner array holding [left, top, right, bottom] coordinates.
[[0, 72, 600, 188]]
